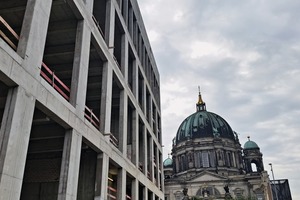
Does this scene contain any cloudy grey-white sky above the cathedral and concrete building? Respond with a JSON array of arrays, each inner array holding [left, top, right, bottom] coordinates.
[[138, 0, 300, 200]]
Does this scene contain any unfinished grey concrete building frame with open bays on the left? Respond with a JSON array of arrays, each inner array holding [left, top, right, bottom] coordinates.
[[0, 0, 164, 200]]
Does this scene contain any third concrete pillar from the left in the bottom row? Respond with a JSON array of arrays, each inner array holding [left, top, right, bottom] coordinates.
[[95, 153, 109, 200]]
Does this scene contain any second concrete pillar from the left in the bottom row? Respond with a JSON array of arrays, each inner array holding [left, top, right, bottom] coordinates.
[[58, 130, 82, 200]]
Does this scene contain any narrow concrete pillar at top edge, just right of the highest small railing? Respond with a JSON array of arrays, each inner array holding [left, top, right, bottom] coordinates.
[[104, 0, 115, 49]]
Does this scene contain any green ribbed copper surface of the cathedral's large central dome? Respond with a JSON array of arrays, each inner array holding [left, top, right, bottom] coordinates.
[[176, 109, 235, 143]]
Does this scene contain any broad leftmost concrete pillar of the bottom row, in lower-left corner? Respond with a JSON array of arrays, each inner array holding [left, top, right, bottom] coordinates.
[[0, 87, 35, 200]]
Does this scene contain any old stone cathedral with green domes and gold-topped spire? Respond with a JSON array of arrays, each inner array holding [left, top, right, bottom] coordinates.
[[163, 92, 272, 200]]
